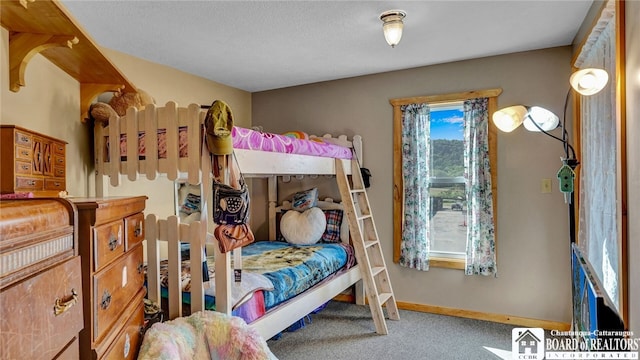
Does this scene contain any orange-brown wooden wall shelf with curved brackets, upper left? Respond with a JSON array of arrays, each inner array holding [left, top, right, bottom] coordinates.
[[0, 0, 136, 121]]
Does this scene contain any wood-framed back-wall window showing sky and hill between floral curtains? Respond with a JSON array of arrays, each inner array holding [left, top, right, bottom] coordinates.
[[390, 89, 502, 275]]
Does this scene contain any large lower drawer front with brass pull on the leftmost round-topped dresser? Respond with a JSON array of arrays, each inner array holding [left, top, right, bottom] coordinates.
[[0, 256, 83, 359]]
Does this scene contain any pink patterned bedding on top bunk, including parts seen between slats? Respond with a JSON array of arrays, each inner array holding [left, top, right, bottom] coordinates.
[[105, 126, 351, 161]]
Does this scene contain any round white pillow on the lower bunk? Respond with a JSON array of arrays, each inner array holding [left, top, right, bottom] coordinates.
[[280, 207, 327, 245]]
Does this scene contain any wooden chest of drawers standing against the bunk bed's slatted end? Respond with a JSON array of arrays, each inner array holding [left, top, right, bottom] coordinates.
[[70, 196, 147, 359]]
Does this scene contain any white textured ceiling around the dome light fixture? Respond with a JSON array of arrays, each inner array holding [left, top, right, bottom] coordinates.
[[63, 0, 592, 92]]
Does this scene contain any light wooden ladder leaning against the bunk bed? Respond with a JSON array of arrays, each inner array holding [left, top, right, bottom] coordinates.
[[336, 154, 400, 335]]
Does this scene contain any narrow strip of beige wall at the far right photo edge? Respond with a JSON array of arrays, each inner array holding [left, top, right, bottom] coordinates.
[[625, 1, 640, 337]]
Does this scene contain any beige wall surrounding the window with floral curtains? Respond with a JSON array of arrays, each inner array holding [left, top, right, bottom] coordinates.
[[252, 47, 571, 323]]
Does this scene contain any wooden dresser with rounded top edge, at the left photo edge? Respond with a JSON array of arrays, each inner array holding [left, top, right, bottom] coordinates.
[[0, 198, 84, 359]]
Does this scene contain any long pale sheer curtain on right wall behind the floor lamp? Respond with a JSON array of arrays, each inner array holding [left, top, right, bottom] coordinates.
[[575, 1, 620, 307]]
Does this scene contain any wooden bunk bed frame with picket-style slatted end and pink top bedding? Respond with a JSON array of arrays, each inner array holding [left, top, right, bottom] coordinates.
[[94, 102, 368, 339]]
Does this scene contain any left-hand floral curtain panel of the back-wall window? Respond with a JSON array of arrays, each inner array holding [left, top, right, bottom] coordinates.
[[400, 104, 431, 271]]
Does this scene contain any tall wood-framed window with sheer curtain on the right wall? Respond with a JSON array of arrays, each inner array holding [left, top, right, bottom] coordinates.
[[573, 1, 630, 316]]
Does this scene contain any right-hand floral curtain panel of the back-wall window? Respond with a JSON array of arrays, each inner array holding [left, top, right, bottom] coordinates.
[[464, 98, 497, 276]]
